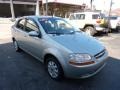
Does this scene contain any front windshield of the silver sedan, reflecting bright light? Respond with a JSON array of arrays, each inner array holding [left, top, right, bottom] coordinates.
[[39, 18, 74, 34]]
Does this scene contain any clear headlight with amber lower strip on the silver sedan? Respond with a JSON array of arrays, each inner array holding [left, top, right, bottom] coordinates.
[[69, 54, 94, 65]]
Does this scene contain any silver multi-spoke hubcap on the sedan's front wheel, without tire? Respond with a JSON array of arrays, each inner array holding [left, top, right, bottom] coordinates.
[[48, 61, 59, 78]]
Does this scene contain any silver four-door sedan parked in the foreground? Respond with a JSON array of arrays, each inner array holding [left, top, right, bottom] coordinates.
[[12, 16, 108, 80]]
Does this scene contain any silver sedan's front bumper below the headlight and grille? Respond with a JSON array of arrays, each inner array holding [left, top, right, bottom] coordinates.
[[65, 53, 108, 78]]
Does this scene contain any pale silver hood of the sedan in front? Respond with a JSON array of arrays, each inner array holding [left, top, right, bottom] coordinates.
[[50, 33, 104, 55]]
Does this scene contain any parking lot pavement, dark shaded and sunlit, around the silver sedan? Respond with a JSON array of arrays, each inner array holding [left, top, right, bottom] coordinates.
[[0, 24, 120, 90]]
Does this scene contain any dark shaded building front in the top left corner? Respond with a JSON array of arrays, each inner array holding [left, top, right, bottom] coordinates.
[[0, 0, 36, 17]]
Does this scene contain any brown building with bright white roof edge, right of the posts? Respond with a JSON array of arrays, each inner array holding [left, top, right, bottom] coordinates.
[[42, 0, 86, 17]]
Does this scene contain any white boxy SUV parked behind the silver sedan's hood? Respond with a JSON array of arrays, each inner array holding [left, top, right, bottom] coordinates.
[[69, 11, 108, 35]]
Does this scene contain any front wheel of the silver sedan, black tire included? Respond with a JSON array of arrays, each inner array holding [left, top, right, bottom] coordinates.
[[46, 57, 63, 80]]
